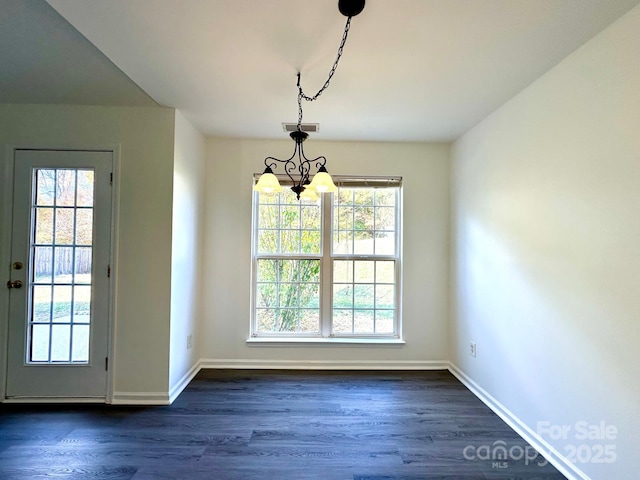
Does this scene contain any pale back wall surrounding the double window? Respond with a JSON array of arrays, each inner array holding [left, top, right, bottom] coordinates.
[[202, 138, 449, 367]]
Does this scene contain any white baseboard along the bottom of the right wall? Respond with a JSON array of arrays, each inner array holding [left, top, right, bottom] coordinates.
[[449, 363, 591, 480]]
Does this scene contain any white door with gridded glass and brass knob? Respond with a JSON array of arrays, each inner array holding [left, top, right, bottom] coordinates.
[[6, 150, 113, 399]]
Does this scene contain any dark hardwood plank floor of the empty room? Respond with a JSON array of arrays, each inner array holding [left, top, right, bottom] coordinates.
[[0, 370, 565, 480]]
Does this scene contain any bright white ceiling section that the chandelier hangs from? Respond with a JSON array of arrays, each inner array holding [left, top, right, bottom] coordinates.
[[7, 0, 640, 141]]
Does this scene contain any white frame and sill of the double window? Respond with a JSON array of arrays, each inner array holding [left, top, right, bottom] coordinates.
[[247, 174, 404, 344]]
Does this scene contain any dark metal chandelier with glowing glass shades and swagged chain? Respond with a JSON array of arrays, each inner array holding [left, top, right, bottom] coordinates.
[[253, 0, 365, 200]]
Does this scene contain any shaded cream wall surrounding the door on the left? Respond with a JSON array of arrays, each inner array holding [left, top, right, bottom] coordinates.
[[0, 105, 174, 396]]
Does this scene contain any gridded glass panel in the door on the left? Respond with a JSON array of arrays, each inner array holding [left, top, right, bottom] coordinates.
[[27, 168, 94, 364]]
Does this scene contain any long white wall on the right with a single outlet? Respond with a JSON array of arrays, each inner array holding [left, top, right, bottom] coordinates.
[[451, 7, 640, 479]]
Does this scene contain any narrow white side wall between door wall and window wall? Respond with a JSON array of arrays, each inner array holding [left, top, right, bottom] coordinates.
[[169, 111, 205, 391]]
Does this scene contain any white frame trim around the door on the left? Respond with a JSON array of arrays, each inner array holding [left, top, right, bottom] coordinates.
[[0, 144, 120, 404]]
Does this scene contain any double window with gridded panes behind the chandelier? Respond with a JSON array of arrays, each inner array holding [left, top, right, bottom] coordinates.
[[251, 178, 400, 338]]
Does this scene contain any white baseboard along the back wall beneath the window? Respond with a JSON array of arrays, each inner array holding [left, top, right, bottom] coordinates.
[[200, 358, 449, 370]]
